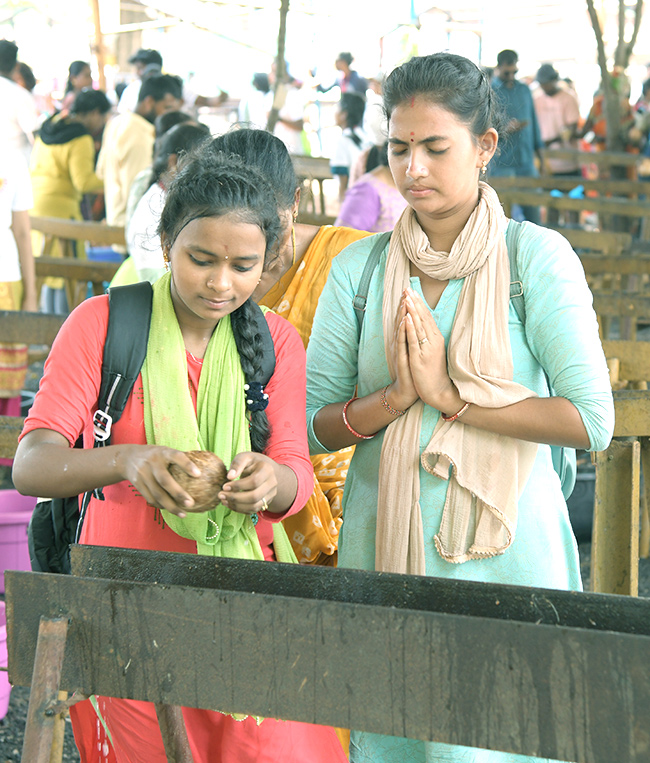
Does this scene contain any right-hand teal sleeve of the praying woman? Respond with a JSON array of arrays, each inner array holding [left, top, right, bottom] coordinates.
[[513, 223, 614, 451]]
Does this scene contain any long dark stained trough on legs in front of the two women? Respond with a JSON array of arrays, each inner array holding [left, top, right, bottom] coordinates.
[[5, 546, 650, 763]]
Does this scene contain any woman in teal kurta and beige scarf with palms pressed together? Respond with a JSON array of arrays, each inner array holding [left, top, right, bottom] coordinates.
[[307, 53, 614, 763]]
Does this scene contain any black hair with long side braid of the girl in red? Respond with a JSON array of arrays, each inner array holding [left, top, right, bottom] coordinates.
[[158, 146, 282, 453]]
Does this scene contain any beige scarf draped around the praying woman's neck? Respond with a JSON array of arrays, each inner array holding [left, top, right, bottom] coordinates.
[[375, 183, 537, 575]]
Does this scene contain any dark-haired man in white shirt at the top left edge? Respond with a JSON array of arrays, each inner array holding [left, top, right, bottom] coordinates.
[[0, 40, 38, 163]]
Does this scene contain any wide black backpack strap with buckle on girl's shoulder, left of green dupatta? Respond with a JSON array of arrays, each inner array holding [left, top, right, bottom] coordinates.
[[93, 281, 153, 445]]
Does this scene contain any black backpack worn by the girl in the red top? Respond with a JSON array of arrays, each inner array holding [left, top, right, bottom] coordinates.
[[27, 281, 275, 574]]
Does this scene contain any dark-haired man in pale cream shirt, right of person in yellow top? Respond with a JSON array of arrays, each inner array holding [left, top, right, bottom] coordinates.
[[97, 74, 182, 231]]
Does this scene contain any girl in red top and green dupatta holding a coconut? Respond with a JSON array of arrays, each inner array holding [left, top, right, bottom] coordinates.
[[14, 151, 347, 763]]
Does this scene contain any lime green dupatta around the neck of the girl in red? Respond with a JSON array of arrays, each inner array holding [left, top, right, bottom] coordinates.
[[142, 273, 297, 563]]
